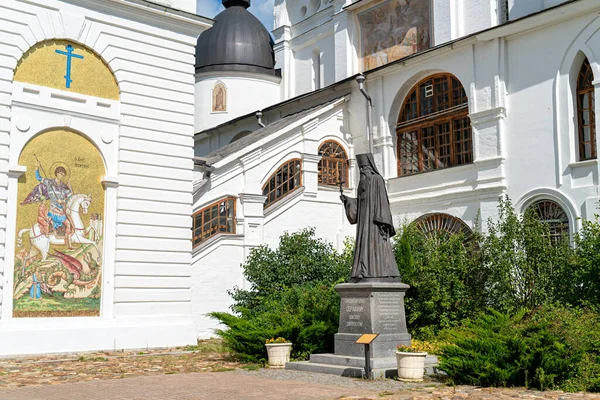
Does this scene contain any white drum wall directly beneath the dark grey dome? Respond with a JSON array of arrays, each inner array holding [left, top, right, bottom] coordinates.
[[194, 72, 281, 132]]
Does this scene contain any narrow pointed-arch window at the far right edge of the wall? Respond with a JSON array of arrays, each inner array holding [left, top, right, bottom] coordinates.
[[577, 58, 597, 161]]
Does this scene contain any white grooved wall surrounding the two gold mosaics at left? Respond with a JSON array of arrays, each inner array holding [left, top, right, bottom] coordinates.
[[0, 0, 209, 355]]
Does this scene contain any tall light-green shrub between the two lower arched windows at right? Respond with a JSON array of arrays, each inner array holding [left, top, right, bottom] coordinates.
[[480, 197, 573, 313]]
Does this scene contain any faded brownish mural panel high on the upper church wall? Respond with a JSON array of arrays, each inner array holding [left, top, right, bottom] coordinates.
[[358, 0, 430, 71]]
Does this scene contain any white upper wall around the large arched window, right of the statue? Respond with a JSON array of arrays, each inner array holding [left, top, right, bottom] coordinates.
[[349, 2, 600, 238]]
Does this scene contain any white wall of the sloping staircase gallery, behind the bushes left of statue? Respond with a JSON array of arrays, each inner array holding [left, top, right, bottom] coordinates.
[[192, 100, 355, 337]]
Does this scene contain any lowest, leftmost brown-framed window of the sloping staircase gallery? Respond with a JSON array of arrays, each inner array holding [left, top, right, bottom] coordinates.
[[192, 197, 235, 247]]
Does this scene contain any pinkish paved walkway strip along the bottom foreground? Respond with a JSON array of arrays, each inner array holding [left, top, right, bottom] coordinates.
[[0, 370, 600, 400]]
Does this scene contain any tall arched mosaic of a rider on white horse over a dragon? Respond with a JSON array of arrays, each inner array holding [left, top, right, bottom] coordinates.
[[13, 129, 105, 318]]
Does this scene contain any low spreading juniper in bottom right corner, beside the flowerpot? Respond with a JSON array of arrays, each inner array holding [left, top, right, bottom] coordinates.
[[439, 305, 600, 391]]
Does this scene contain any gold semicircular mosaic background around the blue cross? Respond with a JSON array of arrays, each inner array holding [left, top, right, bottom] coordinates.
[[14, 40, 119, 100]]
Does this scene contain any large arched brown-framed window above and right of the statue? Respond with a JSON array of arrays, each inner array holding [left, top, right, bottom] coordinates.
[[396, 74, 473, 176]]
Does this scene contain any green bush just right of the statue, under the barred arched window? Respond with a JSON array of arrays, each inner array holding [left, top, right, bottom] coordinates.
[[394, 225, 485, 339]]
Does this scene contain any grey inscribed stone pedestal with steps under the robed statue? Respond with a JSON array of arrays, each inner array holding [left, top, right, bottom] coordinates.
[[286, 282, 410, 378]]
